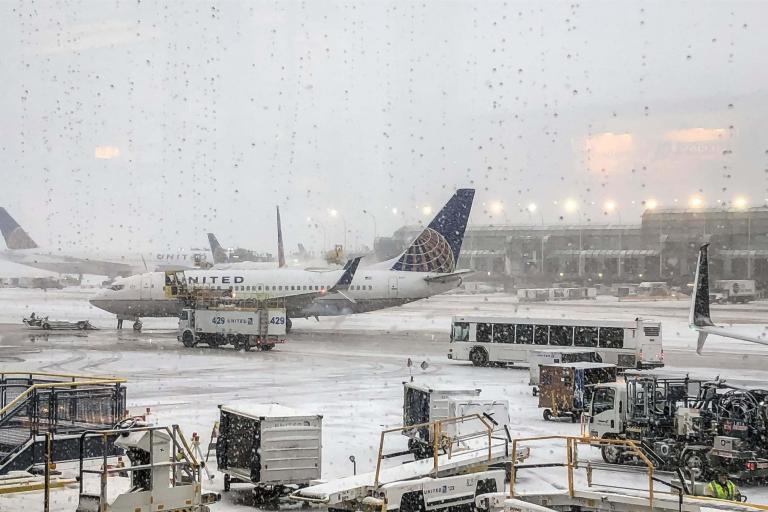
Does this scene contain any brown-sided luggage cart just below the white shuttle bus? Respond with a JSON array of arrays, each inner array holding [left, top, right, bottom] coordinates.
[[539, 362, 616, 422]]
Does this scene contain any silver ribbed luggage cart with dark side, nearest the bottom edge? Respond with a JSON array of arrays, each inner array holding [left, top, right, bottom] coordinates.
[[216, 403, 323, 501]]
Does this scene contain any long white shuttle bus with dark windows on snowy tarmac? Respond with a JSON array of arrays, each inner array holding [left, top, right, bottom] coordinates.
[[448, 316, 664, 369]]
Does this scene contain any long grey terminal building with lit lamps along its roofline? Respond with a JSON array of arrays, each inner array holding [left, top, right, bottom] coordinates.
[[376, 207, 768, 288]]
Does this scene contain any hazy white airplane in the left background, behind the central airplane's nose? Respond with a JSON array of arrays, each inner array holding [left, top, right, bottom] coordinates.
[[0, 207, 213, 277]]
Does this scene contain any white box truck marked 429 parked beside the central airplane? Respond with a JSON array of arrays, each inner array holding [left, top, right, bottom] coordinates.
[[178, 306, 286, 350]]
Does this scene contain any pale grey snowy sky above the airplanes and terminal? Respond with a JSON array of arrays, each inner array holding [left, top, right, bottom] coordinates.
[[0, 0, 768, 254]]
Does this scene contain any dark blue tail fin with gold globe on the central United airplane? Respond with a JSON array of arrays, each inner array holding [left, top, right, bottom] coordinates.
[[392, 188, 475, 273]]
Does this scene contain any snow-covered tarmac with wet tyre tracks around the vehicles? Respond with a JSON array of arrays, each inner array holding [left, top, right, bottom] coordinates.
[[0, 289, 768, 512]]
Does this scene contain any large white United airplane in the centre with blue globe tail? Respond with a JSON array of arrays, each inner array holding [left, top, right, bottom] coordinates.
[[90, 189, 475, 330]]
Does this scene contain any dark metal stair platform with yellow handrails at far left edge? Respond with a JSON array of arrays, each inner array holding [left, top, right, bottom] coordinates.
[[0, 372, 126, 475]]
